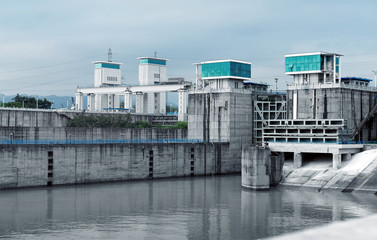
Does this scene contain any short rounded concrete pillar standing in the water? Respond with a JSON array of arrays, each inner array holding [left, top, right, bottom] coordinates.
[[241, 146, 271, 190]]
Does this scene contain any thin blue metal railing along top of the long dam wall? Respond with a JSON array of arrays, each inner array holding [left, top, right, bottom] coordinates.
[[0, 139, 229, 145]]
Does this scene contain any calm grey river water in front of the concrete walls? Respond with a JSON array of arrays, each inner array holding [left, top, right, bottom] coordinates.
[[0, 175, 377, 240]]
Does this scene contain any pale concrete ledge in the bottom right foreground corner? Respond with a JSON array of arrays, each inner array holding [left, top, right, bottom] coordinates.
[[270, 215, 377, 240]]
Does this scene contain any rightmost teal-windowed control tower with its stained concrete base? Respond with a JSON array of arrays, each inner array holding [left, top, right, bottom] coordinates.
[[285, 52, 377, 141]]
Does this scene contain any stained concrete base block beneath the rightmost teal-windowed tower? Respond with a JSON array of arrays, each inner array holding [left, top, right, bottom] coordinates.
[[287, 84, 377, 141]]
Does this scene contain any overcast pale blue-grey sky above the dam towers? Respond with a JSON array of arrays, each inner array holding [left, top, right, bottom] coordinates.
[[0, 0, 377, 96]]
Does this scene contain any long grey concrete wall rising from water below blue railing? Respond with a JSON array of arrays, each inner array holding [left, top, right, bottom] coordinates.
[[0, 143, 235, 189]]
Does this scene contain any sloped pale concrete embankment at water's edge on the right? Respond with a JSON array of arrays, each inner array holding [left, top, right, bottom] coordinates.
[[281, 149, 377, 193]]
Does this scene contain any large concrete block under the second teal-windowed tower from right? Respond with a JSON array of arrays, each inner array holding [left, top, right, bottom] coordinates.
[[187, 89, 253, 172]]
